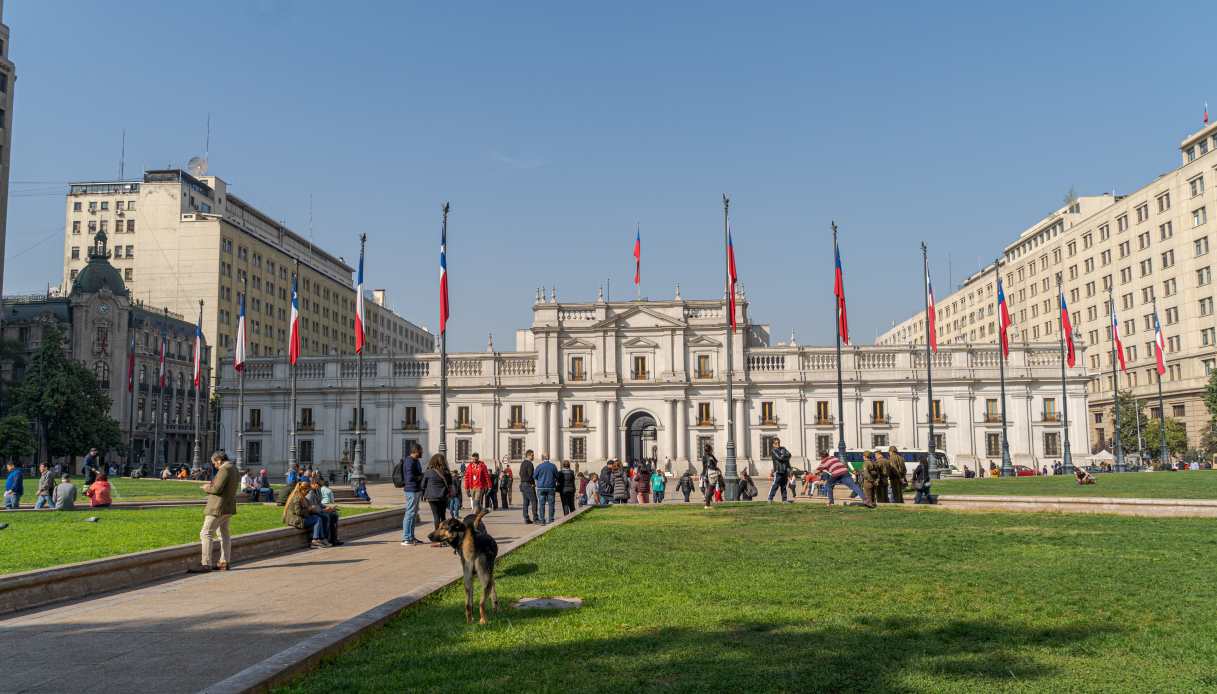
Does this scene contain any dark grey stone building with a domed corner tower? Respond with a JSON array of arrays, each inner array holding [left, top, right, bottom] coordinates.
[[0, 233, 214, 465]]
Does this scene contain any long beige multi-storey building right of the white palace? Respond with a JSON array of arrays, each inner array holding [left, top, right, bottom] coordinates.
[[876, 124, 1217, 449]]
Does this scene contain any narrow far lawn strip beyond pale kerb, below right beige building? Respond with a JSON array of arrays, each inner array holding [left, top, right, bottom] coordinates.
[[933, 470, 1217, 499]]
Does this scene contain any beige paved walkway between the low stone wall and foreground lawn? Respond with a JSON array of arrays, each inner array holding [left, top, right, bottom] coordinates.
[[0, 487, 569, 694]]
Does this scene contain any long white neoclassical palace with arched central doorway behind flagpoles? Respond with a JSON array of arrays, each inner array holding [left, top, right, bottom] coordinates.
[[218, 292, 1090, 477]]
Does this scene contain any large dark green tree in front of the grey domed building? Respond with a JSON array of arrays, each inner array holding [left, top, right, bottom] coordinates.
[[11, 329, 122, 465]]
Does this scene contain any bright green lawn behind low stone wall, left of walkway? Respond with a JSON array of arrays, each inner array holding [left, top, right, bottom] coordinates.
[[0, 504, 380, 575]]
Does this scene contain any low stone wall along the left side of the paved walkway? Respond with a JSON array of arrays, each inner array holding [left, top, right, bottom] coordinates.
[[0, 509, 402, 615]]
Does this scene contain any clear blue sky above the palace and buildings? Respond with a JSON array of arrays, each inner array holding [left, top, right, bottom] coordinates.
[[4, 0, 1217, 349]]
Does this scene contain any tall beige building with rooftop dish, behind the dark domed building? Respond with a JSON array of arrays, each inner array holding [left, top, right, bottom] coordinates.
[[63, 169, 430, 368]]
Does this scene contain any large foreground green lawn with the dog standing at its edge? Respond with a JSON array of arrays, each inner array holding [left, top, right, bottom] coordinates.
[[286, 504, 1217, 694]]
